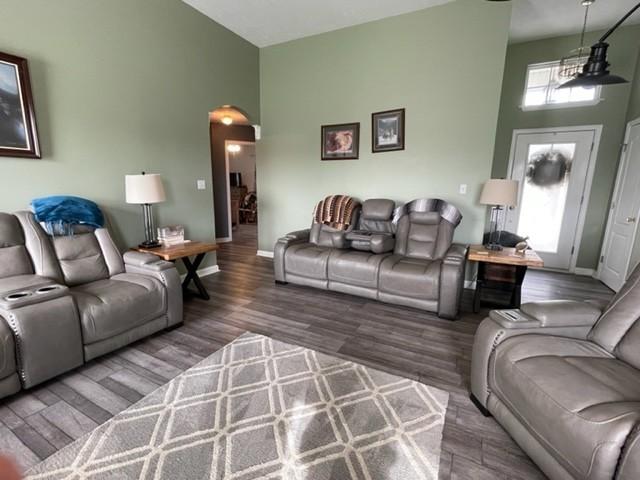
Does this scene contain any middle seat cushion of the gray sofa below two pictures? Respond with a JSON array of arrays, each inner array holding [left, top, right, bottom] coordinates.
[[328, 250, 387, 288]]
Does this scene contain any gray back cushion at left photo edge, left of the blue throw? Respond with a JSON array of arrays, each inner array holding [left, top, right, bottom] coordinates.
[[0, 213, 33, 278]]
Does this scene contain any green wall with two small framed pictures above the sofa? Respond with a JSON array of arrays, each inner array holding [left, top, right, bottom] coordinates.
[[257, 0, 510, 251]]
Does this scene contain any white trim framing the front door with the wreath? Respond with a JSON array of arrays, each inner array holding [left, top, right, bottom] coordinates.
[[507, 125, 602, 273]]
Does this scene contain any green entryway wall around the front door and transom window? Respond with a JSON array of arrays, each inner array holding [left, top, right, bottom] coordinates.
[[493, 26, 640, 269]]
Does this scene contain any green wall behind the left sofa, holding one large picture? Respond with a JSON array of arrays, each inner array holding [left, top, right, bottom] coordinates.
[[0, 0, 259, 261]]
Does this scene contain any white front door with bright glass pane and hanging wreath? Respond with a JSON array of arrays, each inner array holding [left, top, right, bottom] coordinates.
[[506, 127, 599, 270]]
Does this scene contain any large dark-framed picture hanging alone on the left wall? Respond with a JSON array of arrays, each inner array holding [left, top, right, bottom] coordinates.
[[0, 52, 40, 158]]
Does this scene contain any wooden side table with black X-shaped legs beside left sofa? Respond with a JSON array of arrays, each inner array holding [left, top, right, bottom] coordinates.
[[132, 242, 219, 300]]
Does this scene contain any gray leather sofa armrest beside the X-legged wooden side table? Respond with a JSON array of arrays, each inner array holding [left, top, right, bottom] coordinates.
[[123, 252, 183, 327]]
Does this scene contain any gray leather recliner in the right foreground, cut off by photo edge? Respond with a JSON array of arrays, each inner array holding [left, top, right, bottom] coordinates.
[[471, 267, 640, 480]]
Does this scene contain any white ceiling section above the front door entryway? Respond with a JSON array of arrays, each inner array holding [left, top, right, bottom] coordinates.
[[510, 0, 640, 43]]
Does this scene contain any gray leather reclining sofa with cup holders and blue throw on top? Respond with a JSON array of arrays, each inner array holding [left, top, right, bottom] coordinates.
[[0, 212, 182, 397]]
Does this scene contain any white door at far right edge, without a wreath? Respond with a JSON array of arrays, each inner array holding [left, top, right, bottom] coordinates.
[[599, 119, 640, 292]]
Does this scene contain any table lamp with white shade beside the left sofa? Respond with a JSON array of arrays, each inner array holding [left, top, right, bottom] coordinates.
[[125, 172, 166, 248]]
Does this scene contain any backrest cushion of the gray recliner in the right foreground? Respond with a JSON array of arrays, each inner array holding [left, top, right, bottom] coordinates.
[[589, 265, 640, 362]]
